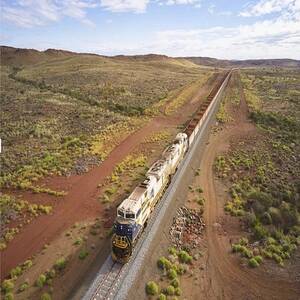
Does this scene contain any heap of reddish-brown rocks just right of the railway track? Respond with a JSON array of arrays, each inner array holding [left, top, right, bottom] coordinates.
[[169, 206, 205, 248]]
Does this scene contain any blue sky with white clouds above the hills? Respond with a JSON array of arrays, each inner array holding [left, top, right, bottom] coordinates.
[[0, 0, 300, 59]]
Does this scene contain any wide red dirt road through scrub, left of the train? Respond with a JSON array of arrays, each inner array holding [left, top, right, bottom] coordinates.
[[1, 72, 215, 278]]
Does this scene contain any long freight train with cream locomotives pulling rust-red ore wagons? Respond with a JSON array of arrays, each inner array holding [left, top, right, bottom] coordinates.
[[111, 71, 231, 264]]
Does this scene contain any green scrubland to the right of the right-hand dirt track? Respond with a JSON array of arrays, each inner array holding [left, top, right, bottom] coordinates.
[[218, 70, 300, 267]]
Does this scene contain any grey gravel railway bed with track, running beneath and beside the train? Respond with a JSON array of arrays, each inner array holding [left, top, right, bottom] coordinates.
[[83, 72, 231, 300]]
